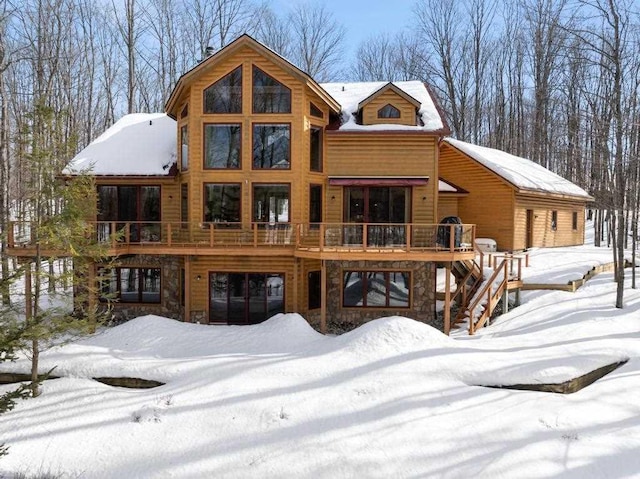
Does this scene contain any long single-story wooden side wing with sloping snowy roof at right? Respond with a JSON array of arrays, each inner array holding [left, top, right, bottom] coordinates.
[[439, 138, 593, 251]]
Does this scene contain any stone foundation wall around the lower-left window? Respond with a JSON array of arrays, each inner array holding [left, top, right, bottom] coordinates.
[[102, 255, 184, 322]]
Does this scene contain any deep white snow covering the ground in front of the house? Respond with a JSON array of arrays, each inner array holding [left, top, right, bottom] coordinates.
[[0, 226, 640, 478]]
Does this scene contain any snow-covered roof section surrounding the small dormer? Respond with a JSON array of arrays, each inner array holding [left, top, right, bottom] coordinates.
[[320, 81, 445, 131]]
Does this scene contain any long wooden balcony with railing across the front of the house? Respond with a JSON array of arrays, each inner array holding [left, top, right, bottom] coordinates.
[[7, 222, 475, 261]]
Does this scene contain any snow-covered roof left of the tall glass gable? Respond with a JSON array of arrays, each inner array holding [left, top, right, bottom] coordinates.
[[63, 113, 177, 176]]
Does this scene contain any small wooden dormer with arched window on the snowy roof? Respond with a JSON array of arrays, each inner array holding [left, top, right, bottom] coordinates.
[[358, 83, 420, 126]]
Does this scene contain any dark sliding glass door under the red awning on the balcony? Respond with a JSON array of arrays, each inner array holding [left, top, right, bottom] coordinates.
[[343, 186, 411, 246]]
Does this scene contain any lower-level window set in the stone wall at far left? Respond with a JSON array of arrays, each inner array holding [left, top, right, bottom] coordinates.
[[98, 267, 161, 303]]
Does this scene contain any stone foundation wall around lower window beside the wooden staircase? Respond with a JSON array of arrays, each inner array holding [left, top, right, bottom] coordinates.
[[328, 261, 437, 333]]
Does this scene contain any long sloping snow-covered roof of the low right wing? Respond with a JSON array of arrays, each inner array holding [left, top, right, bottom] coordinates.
[[444, 138, 591, 200]]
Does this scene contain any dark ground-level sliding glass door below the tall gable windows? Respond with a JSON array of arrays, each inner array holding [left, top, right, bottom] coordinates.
[[209, 273, 284, 324]]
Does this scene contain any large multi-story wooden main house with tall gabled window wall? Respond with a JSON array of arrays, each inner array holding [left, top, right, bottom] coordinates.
[[5, 35, 584, 331]]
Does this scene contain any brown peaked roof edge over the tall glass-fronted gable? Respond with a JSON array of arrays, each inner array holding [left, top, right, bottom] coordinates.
[[165, 33, 340, 118]]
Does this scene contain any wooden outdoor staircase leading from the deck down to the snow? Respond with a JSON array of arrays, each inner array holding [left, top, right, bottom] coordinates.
[[451, 248, 528, 334]]
